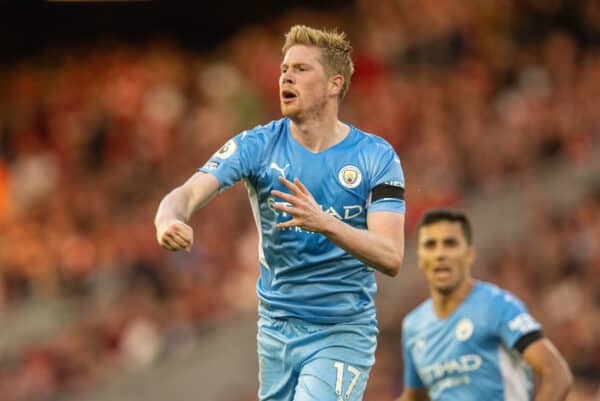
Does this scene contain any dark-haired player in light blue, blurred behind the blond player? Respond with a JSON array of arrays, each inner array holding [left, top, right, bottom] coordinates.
[[398, 209, 572, 401]]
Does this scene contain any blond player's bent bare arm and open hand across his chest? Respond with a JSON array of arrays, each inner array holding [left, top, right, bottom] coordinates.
[[272, 177, 404, 276]]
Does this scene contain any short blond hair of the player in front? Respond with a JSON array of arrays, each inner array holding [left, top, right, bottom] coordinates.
[[281, 25, 354, 100]]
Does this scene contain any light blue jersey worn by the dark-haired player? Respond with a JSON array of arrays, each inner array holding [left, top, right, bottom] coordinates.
[[402, 282, 541, 401]]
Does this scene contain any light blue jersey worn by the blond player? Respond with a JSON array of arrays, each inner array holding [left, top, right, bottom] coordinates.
[[199, 118, 405, 324]]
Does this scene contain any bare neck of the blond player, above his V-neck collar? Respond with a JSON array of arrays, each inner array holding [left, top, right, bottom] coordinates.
[[290, 115, 350, 153]]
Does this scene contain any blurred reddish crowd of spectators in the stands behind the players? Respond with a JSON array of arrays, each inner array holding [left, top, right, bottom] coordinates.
[[0, 0, 600, 401]]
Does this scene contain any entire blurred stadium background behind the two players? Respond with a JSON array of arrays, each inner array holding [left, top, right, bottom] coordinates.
[[0, 0, 600, 401]]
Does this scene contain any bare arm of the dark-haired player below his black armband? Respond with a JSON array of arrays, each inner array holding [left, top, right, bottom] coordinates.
[[523, 338, 573, 401]]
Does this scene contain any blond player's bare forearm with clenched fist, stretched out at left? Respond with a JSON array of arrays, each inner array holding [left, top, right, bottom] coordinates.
[[154, 172, 219, 251]]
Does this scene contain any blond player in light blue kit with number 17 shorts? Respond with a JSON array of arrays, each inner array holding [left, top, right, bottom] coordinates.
[[155, 26, 405, 401]]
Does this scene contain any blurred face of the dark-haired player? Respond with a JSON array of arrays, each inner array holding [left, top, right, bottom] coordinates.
[[418, 221, 474, 294]]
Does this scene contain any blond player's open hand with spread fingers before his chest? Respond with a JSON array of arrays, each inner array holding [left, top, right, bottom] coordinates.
[[271, 176, 334, 232]]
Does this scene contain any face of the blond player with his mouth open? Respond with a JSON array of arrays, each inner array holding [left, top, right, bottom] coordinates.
[[279, 45, 328, 119]]
